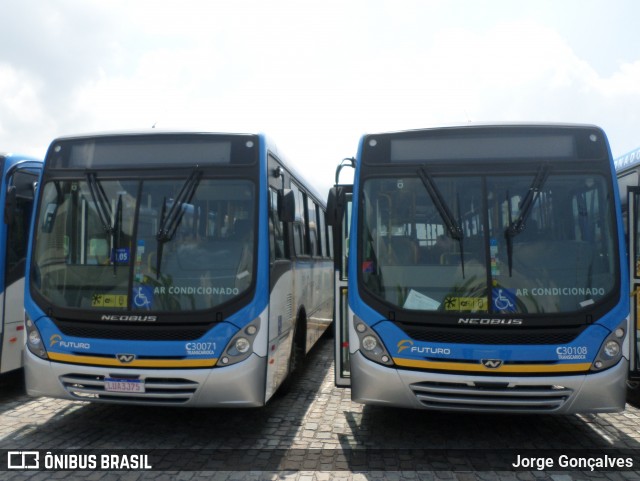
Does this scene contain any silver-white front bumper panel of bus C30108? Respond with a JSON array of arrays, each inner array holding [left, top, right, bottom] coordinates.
[[351, 351, 629, 414]]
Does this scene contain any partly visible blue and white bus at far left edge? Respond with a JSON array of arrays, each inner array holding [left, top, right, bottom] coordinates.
[[0, 154, 42, 374]]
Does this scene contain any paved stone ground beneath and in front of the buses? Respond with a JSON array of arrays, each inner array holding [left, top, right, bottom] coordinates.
[[0, 339, 640, 481]]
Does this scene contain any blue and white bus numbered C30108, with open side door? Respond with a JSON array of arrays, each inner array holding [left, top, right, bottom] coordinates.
[[327, 125, 631, 414]]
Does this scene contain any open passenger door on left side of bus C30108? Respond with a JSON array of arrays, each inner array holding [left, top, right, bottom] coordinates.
[[327, 185, 353, 387]]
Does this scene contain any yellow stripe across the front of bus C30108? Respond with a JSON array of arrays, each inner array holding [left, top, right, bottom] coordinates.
[[393, 357, 591, 373]]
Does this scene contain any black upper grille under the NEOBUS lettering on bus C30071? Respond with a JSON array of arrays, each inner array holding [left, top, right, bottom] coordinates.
[[54, 319, 213, 341]]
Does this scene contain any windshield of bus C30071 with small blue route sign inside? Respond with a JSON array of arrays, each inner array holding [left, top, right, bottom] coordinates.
[[32, 175, 256, 312]]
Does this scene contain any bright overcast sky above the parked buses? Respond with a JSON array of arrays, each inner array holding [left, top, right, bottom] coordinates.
[[0, 0, 640, 195]]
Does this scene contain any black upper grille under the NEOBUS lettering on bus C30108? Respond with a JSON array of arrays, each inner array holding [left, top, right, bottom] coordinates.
[[397, 322, 586, 345]]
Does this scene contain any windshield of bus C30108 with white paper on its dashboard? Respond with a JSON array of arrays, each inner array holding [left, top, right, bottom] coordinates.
[[359, 169, 618, 314]]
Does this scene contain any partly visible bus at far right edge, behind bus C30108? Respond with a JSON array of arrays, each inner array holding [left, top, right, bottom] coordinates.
[[614, 144, 640, 388]]
